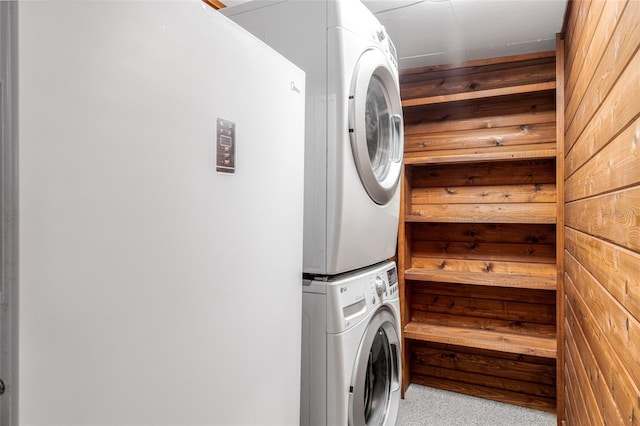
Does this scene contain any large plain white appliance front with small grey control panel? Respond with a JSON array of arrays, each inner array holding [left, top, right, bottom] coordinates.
[[19, 1, 305, 425]]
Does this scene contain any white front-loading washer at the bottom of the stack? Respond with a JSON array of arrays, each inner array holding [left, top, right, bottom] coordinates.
[[300, 262, 402, 426]]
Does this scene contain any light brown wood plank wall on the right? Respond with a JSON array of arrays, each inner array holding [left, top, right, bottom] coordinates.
[[559, 0, 640, 425]]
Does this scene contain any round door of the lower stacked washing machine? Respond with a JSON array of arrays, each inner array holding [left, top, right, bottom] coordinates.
[[349, 308, 400, 426]]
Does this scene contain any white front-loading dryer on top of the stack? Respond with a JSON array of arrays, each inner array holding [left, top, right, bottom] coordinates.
[[221, 0, 404, 275]]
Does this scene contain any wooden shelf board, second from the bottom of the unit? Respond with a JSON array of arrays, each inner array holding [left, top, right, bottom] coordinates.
[[404, 262, 557, 290]]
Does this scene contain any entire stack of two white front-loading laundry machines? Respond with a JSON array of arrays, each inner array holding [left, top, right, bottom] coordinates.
[[221, 0, 403, 425]]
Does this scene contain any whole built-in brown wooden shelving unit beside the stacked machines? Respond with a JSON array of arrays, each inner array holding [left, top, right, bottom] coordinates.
[[398, 52, 561, 411]]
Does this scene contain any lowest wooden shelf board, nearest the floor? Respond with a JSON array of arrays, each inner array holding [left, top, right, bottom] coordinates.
[[404, 316, 557, 358]]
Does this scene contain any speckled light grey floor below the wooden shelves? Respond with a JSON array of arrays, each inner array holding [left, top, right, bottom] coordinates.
[[396, 384, 556, 426]]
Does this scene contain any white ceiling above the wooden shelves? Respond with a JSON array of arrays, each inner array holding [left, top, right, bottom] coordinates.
[[223, 0, 567, 69]]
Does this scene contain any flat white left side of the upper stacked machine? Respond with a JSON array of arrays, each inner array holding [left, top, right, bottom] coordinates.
[[221, 0, 336, 274]]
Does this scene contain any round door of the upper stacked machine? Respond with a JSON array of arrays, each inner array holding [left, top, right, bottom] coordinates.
[[349, 49, 404, 204]]
